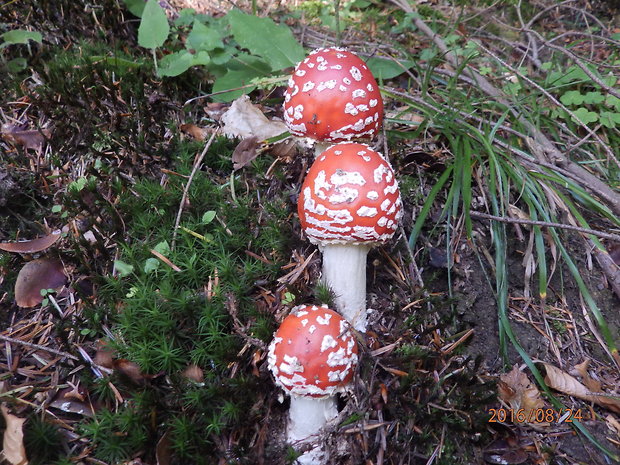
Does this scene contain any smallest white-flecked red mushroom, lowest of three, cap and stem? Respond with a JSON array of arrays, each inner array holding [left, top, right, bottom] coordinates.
[[267, 305, 357, 456]]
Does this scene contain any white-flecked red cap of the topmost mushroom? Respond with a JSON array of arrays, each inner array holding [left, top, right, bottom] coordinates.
[[284, 48, 383, 142]]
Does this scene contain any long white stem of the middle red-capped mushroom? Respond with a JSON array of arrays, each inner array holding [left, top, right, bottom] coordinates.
[[322, 244, 370, 333]]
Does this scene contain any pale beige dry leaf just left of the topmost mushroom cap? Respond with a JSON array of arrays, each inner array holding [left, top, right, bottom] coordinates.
[[221, 95, 288, 141]]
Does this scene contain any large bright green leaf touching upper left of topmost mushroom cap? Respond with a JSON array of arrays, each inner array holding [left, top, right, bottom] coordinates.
[[227, 10, 305, 71]]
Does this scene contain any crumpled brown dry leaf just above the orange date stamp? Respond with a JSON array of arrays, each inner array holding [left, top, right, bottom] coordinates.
[[498, 365, 545, 426]]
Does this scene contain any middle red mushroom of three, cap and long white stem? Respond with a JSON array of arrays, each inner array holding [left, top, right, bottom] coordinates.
[[297, 142, 402, 332]]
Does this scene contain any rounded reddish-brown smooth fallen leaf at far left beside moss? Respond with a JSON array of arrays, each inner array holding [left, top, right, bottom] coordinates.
[[15, 258, 67, 307]]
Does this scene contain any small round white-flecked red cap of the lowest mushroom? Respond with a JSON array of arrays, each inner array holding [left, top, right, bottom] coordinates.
[[268, 305, 357, 397]]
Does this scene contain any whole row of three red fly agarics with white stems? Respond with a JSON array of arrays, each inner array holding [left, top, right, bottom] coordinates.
[[268, 48, 402, 464]]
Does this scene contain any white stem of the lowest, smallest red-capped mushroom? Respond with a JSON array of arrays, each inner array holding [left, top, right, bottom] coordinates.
[[288, 394, 338, 442]]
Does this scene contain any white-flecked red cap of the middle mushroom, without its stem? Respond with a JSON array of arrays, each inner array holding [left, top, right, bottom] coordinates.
[[297, 142, 402, 244]]
